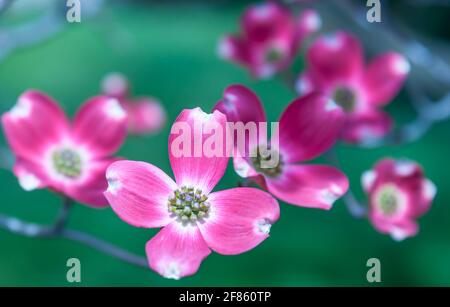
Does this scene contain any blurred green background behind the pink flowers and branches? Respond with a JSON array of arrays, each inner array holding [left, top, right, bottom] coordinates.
[[0, 0, 450, 286]]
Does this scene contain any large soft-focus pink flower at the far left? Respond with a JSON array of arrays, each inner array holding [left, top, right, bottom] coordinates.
[[2, 91, 127, 207]]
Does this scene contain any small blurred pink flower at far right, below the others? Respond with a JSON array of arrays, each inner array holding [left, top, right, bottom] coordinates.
[[362, 159, 436, 241]]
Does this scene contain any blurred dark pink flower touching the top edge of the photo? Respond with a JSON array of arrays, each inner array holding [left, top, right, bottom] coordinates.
[[218, 2, 321, 78]]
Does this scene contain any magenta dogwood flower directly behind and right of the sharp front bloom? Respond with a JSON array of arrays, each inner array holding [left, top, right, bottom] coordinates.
[[215, 85, 348, 209]]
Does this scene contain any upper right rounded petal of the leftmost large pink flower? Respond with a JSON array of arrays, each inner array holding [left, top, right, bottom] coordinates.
[[73, 96, 127, 157]]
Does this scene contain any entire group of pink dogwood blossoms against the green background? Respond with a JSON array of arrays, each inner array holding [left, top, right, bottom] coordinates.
[[2, 2, 436, 279]]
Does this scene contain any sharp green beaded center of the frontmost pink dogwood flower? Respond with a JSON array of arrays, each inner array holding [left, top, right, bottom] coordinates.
[[168, 186, 210, 223]]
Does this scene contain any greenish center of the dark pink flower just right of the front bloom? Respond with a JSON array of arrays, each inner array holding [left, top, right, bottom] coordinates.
[[251, 147, 283, 177]]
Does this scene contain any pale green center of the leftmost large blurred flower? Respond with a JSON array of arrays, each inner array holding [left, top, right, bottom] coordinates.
[[52, 148, 81, 178]]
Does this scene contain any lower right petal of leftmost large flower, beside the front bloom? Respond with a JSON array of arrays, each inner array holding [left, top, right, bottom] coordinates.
[[65, 158, 118, 208]]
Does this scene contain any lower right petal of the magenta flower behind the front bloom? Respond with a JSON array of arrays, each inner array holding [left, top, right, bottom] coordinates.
[[265, 165, 349, 210]]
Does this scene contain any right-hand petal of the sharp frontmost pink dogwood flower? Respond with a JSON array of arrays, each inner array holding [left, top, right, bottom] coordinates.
[[198, 188, 280, 255]]
